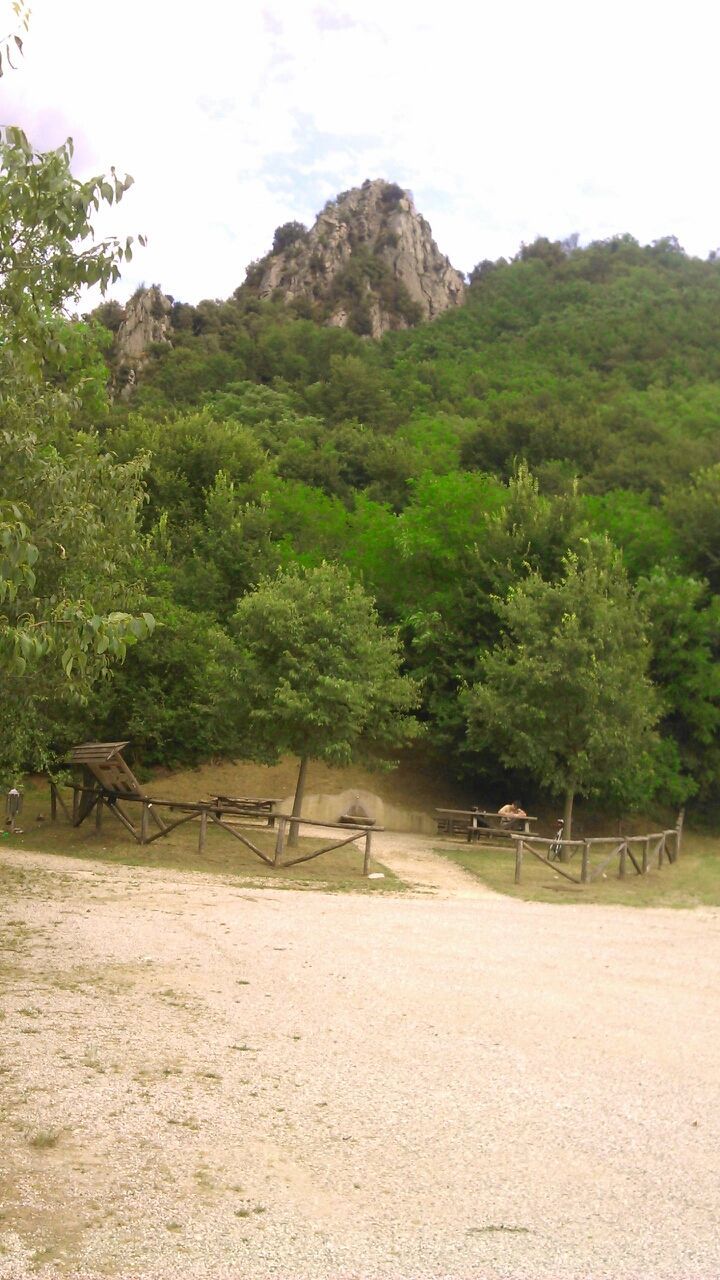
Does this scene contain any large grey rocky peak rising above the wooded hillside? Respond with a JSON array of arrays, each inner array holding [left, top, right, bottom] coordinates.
[[243, 179, 465, 338]]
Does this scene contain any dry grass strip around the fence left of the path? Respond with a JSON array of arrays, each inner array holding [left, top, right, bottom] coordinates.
[[4, 786, 404, 893]]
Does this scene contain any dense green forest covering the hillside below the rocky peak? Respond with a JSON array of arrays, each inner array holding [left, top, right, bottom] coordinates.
[[4, 127, 720, 805]]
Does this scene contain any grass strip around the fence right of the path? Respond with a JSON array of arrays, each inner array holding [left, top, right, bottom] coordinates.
[[436, 833, 720, 908]]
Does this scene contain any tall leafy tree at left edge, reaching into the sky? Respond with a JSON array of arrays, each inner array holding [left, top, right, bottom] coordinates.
[[0, 128, 154, 773]]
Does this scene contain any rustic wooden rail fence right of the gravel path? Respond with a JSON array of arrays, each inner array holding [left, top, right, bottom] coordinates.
[[512, 813, 684, 884]]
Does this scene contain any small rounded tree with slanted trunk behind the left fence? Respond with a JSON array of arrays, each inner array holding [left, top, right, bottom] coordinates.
[[232, 563, 418, 841]]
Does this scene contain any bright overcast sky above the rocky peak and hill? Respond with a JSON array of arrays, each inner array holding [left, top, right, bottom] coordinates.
[[0, 0, 720, 302]]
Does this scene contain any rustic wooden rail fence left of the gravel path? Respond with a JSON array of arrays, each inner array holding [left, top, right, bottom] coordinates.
[[50, 782, 383, 876]]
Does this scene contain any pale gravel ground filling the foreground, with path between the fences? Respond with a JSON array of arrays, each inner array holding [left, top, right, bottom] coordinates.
[[0, 837, 720, 1280]]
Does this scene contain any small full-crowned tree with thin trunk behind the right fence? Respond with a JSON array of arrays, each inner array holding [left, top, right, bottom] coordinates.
[[466, 544, 659, 838]]
